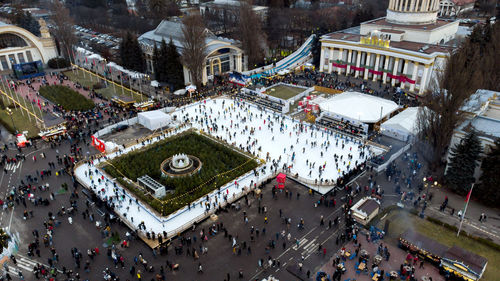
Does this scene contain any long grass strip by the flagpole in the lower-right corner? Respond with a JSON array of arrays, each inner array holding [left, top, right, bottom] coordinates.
[[379, 211, 500, 281]]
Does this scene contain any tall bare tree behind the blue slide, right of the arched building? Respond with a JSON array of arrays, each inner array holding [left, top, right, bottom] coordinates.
[[238, 0, 264, 67]]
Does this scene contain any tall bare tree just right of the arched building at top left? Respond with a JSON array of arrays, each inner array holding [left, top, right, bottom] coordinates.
[[52, 0, 76, 60]]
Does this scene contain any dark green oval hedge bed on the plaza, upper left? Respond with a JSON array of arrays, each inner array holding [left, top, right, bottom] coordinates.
[[40, 85, 94, 111]]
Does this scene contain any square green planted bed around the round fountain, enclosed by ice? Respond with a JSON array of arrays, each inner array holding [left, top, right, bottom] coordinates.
[[104, 131, 258, 215]]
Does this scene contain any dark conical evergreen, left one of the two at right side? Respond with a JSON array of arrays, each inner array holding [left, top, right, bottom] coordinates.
[[446, 130, 482, 194]]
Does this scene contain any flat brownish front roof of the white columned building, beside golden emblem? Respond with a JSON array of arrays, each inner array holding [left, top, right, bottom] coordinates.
[[321, 31, 454, 55]]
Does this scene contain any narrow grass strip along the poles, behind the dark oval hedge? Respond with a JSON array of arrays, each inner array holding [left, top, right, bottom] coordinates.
[[64, 70, 146, 100]]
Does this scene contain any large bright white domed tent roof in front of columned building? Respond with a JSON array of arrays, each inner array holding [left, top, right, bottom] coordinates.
[[319, 92, 399, 123]]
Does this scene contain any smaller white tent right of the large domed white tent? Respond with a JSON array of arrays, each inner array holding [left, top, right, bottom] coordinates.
[[380, 107, 418, 141]]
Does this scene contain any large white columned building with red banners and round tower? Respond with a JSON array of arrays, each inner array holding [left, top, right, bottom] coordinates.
[[320, 0, 459, 95]]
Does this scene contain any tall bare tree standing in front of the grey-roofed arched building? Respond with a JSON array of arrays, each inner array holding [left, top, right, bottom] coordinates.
[[182, 14, 207, 87]]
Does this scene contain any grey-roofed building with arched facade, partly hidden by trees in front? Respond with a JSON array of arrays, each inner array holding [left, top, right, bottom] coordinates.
[[139, 20, 247, 84]]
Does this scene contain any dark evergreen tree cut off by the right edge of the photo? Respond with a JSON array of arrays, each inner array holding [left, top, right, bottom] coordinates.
[[474, 138, 500, 207]]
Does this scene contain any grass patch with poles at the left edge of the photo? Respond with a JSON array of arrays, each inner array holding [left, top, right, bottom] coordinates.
[[0, 103, 40, 138]]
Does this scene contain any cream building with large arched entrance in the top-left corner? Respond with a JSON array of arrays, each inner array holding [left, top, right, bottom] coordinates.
[[0, 19, 57, 70]]
